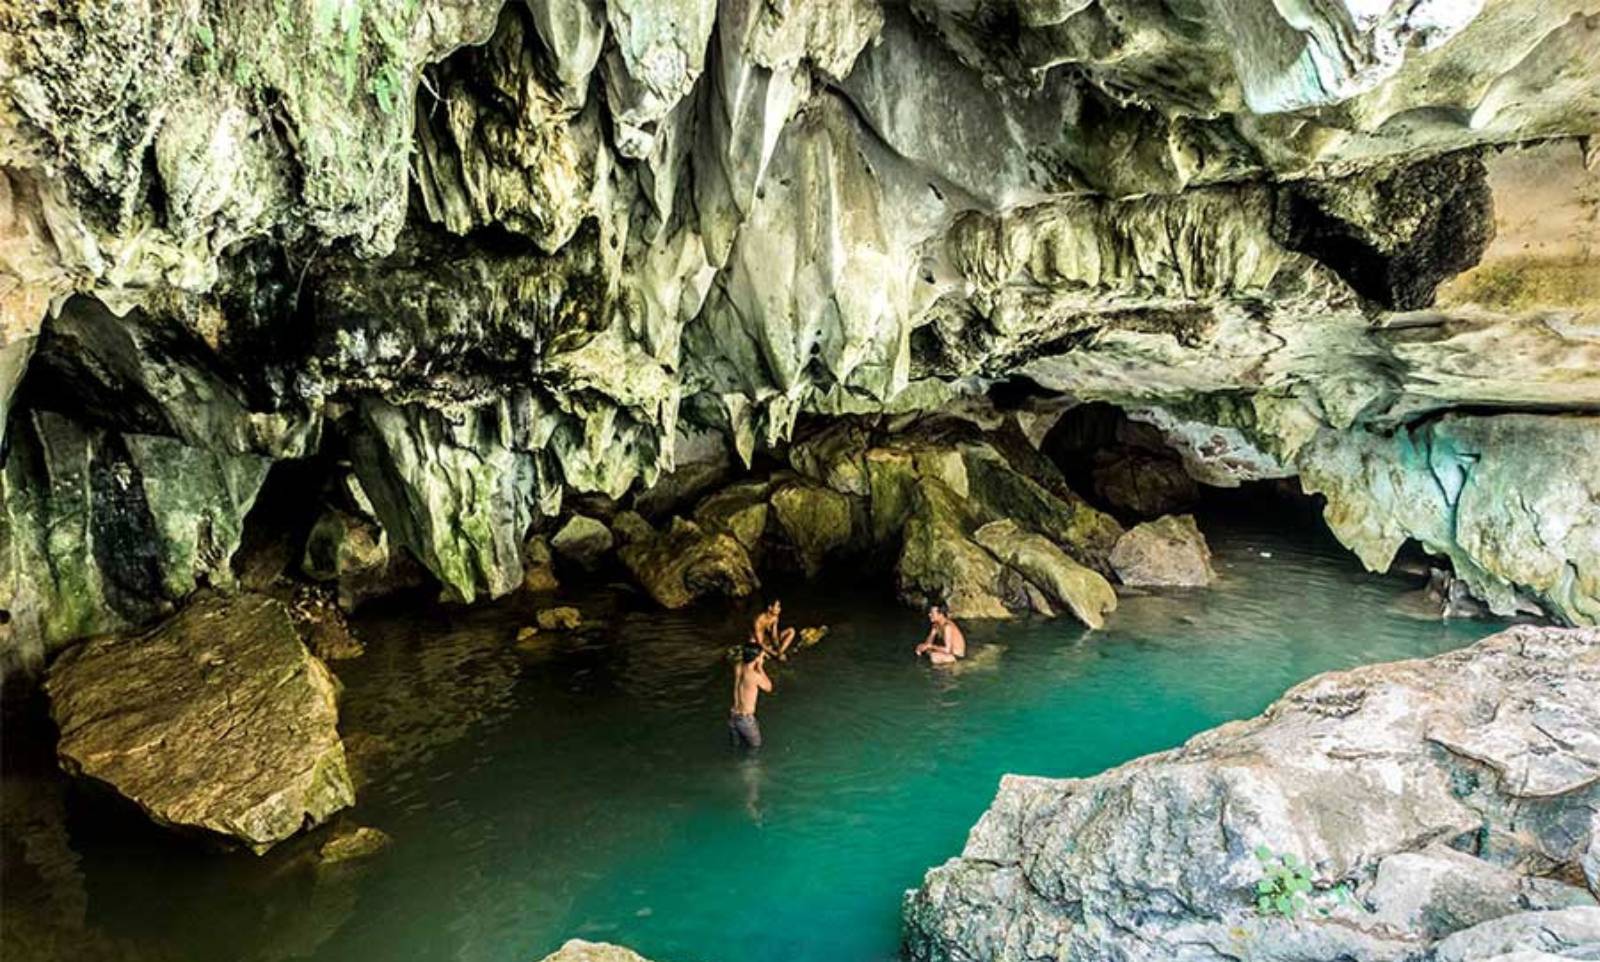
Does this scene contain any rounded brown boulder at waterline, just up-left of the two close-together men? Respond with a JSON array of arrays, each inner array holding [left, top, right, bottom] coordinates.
[[618, 517, 760, 608]]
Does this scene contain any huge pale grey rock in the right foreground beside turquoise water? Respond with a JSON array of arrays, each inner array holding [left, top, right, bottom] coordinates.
[[906, 626, 1600, 962]]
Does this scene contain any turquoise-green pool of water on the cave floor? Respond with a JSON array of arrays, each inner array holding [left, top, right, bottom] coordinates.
[[0, 523, 1498, 962]]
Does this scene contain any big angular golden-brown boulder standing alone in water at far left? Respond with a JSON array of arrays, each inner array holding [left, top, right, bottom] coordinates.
[[45, 594, 355, 852]]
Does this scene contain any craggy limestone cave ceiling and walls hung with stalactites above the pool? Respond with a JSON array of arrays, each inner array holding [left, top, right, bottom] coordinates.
[[0, 0, 1600, 659]]
